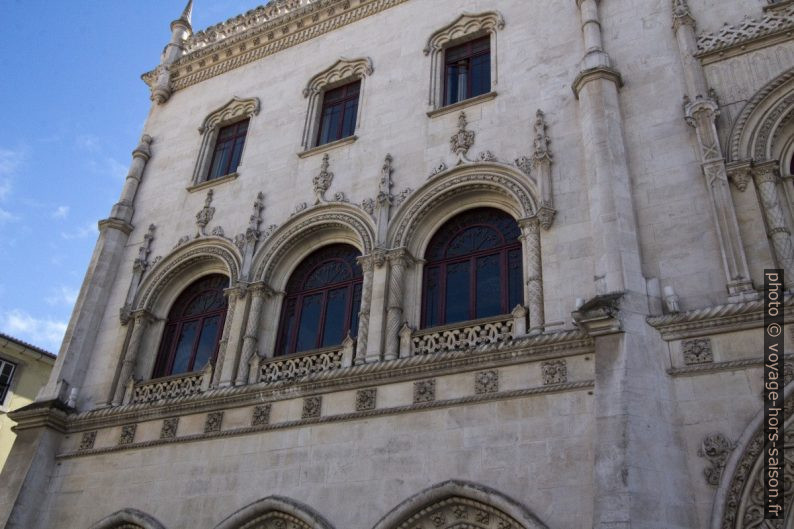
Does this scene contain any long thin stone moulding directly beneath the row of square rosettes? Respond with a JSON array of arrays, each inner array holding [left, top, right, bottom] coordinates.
[[56, 380, 595, 459]]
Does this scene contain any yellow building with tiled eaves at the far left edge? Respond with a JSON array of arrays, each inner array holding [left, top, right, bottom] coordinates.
[[0, 336, 55, 470]]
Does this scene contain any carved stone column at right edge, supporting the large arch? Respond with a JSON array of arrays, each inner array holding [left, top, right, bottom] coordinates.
[[753, 161, 794, 290]]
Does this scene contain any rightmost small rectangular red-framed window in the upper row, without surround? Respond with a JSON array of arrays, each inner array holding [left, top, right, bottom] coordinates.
[[444, 37, 491, 105]]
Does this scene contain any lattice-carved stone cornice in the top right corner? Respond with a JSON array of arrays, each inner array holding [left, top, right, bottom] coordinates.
[[697, 3, 794, 64]]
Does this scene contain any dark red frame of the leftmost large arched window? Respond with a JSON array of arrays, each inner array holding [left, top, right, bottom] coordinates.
[[152, 274, 229, 378]]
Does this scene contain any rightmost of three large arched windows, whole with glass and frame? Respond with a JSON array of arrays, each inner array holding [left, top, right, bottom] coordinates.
[[422, 208, 522, 327]]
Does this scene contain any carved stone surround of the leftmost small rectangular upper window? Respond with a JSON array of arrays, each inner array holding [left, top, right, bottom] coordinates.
[[188, 96, 260, 191]]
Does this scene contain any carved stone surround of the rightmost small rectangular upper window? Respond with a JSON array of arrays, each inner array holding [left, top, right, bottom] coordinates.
[[423, 11, 505, 113]]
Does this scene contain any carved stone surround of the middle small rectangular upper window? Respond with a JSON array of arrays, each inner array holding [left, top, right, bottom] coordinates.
[[298, 57, 374, 158]]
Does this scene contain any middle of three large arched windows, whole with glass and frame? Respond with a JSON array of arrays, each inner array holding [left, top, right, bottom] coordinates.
[[276, 244, 362, 355]]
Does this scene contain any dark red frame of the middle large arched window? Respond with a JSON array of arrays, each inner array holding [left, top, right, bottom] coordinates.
[[276, 244, 363, 356]]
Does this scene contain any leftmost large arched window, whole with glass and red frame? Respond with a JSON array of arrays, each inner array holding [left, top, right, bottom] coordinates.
[[153, 274, 229, 377]]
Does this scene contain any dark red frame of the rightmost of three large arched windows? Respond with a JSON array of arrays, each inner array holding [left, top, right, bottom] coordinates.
[[421, 208, 523, 328]]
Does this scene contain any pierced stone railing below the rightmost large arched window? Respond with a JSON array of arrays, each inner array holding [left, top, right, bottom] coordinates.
[[400, 307, 526, 356]]
